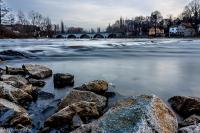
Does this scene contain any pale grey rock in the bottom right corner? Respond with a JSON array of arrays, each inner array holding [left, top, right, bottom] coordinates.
[[178, 124, 200, 133]]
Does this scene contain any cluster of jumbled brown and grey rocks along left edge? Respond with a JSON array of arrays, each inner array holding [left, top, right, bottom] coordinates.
[[0, 64, 52, 129]]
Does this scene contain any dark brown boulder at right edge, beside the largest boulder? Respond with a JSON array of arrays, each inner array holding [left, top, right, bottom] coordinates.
[[169, 96, 200, 118]]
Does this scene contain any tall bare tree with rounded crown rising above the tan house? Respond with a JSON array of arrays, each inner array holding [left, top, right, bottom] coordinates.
[[151, 11, 163, 36]]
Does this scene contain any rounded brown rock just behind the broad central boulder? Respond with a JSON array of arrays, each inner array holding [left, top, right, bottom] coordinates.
[[75, 80, 108, 95]]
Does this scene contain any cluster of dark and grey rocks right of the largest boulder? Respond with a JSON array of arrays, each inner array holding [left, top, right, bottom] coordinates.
[[169, 96, 200, 133]]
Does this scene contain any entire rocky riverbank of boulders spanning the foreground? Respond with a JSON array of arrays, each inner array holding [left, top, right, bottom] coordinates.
[[0, 64, 200, 133]]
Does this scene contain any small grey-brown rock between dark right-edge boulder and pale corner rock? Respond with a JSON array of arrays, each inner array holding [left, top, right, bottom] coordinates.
[[179, 115, 200, 127]]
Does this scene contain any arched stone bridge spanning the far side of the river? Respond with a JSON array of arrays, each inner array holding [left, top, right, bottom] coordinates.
[[54, 33, 122, 39]]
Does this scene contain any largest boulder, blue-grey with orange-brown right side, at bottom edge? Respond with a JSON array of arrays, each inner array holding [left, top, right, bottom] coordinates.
[[73, 96, 178, 133]]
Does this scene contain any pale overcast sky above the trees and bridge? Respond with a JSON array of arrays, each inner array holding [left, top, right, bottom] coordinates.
[[7, 0, 189, 28]]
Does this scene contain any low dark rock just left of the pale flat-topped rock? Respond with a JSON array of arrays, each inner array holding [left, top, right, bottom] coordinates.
[[6, 66, 26, 75]]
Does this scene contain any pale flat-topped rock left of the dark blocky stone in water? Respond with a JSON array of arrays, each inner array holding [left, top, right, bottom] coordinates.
[[22, 64, 52, 79]]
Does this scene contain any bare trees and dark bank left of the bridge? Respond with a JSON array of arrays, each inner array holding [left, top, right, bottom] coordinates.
[[0, 0, 59, 37]]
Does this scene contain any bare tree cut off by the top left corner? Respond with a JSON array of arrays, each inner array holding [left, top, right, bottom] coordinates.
[[0, 0, 9, 25]]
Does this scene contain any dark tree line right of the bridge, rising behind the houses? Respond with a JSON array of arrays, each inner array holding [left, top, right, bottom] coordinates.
[[106, 0, 200, 36]]
